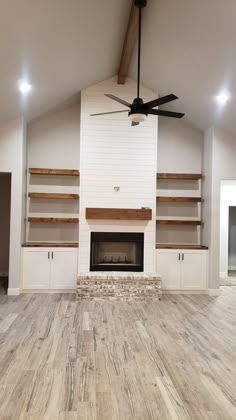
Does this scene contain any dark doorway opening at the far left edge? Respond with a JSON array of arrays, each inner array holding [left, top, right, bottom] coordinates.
[[0, 173, 11, 294]]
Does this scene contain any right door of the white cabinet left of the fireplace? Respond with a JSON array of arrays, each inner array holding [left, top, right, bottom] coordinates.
[[51, 249, 78, 289]]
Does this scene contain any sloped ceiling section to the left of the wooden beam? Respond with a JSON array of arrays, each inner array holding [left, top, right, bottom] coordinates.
[[0, 0, 130, 120]]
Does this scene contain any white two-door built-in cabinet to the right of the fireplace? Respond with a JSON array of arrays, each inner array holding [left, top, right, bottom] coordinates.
[[156, 249, 208, 291]]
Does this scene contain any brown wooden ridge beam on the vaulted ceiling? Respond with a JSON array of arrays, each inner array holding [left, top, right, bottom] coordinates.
[[117, 0, 138, 85]]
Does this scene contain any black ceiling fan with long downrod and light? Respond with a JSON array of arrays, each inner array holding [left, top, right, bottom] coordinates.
[[91, 0, 184, 126]]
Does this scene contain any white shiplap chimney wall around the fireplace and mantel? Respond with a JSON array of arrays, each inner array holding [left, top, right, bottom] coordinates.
[[79, 78, 157, 272]]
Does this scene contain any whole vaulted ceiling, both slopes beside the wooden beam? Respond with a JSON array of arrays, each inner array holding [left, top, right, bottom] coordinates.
[[0, 0, 236, 133]]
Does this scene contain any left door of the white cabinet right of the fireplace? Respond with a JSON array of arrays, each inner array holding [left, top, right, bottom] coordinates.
[[156, 251, 181, 289]]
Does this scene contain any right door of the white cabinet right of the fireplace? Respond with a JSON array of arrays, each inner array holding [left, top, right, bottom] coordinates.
[[181, 251, 207, 290]]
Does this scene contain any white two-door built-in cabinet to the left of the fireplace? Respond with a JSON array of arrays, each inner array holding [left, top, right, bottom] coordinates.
[[22, 247, 78, 290]]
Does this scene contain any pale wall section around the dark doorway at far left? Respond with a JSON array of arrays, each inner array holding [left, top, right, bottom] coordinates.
[[0, 120, 25, 292]]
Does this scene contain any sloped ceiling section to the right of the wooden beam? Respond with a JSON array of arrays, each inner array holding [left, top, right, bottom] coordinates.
[[129, 0, 236, 133]]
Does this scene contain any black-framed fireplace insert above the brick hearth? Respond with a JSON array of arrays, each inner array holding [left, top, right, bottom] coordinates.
[[90, 232, 144, 272]]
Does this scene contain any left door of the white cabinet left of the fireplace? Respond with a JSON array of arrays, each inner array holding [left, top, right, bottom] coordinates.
[[22, 249, 50, 289]]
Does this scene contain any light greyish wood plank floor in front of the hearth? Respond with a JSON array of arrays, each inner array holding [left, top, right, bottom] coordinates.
[[0, 287, 236, 420]]
